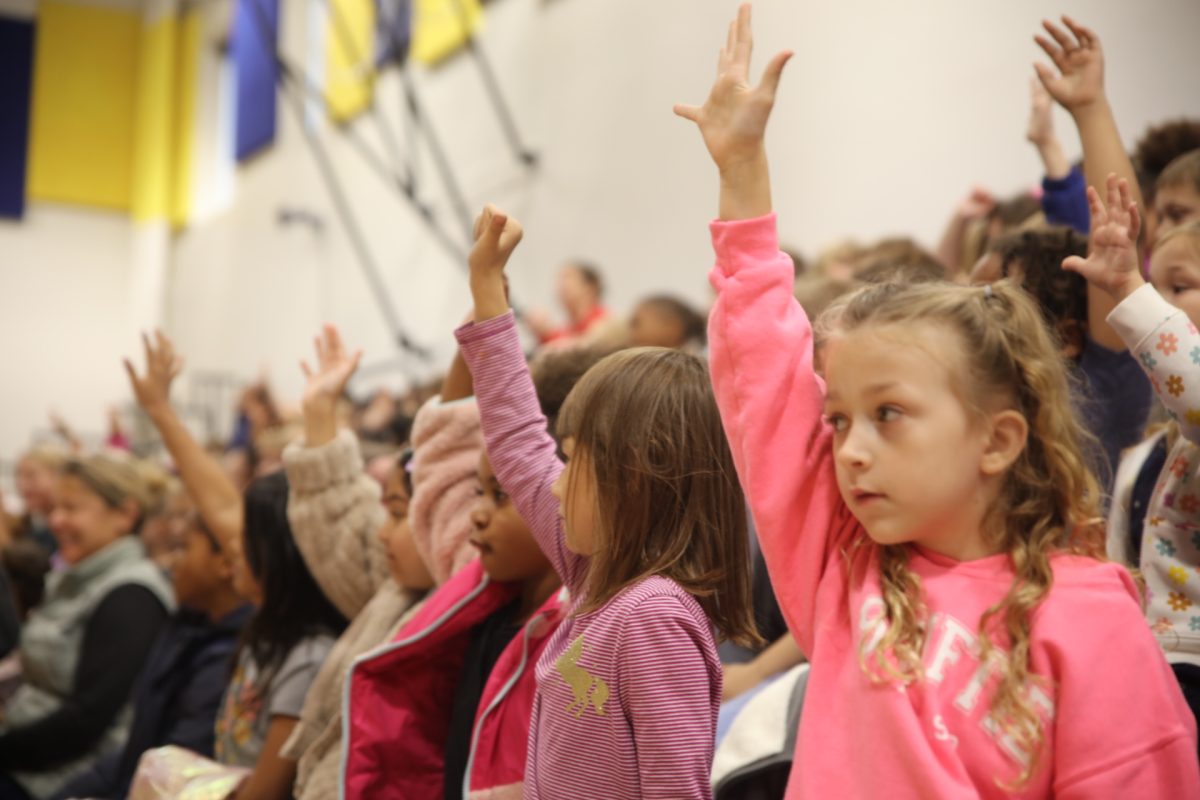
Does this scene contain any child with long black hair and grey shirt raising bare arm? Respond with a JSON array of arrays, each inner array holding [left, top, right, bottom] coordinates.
[[125, 333, 346, 800]]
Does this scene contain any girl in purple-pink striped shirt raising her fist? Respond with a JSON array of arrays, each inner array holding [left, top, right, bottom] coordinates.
[[457, 206, 753, 799]]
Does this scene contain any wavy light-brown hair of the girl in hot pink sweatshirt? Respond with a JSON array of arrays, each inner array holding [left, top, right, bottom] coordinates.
[[827, 281, 1105, 784]]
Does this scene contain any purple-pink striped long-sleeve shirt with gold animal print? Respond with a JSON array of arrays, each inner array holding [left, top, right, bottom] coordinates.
[[457, 314, 721, 800]]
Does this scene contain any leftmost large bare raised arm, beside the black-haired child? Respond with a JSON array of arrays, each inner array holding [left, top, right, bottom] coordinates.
[[125, 331, 245, 553]]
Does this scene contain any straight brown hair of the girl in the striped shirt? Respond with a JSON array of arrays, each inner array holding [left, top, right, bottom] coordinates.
[[558, 348, 758, 644]]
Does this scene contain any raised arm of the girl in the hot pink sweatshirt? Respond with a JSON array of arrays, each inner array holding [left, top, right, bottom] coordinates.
[[676, 5, 859, 655]]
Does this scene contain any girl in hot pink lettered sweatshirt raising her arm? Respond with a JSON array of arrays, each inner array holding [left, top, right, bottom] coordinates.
[[677, 6, 1200, 798]]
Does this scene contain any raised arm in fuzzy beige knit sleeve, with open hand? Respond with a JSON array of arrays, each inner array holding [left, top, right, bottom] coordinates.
[[283, 325, 388, 619]]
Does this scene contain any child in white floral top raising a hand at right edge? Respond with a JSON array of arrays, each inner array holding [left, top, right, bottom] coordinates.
[[1080, 175, 1200, 738]]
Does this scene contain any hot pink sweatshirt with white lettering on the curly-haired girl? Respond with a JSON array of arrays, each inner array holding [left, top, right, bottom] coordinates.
[[709, 215, 1200, 798]]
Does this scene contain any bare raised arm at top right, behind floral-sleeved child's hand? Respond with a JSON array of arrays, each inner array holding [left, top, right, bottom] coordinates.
[[1033, 17, 1142, 350]]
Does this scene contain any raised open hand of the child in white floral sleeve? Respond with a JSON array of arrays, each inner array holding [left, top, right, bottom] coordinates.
[[1062, 174, 1145, 302]]
